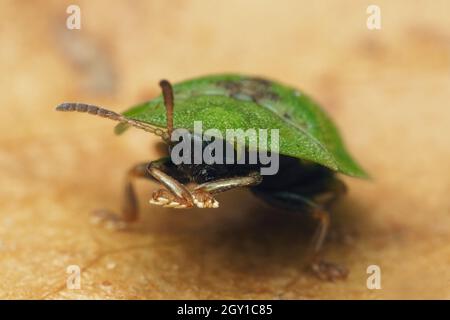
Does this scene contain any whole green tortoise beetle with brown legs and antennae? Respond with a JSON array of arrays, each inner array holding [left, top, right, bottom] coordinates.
[[57, 74, 368, 280]]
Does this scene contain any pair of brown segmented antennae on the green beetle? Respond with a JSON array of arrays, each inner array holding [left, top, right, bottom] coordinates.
[[56, 80, 179, 145]]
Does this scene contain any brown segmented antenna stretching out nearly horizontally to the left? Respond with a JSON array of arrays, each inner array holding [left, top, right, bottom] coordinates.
[[56, 103, 167, 139]]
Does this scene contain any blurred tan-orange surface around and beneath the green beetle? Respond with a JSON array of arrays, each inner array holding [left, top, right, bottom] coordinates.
[[0, 0, 450, 299]]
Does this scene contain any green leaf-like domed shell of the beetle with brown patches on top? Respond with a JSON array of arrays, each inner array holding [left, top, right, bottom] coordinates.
[[116, 74, 367, 178]]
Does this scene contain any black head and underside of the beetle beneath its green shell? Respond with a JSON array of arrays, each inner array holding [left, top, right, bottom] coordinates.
[[165, 137, 345, 212]]
